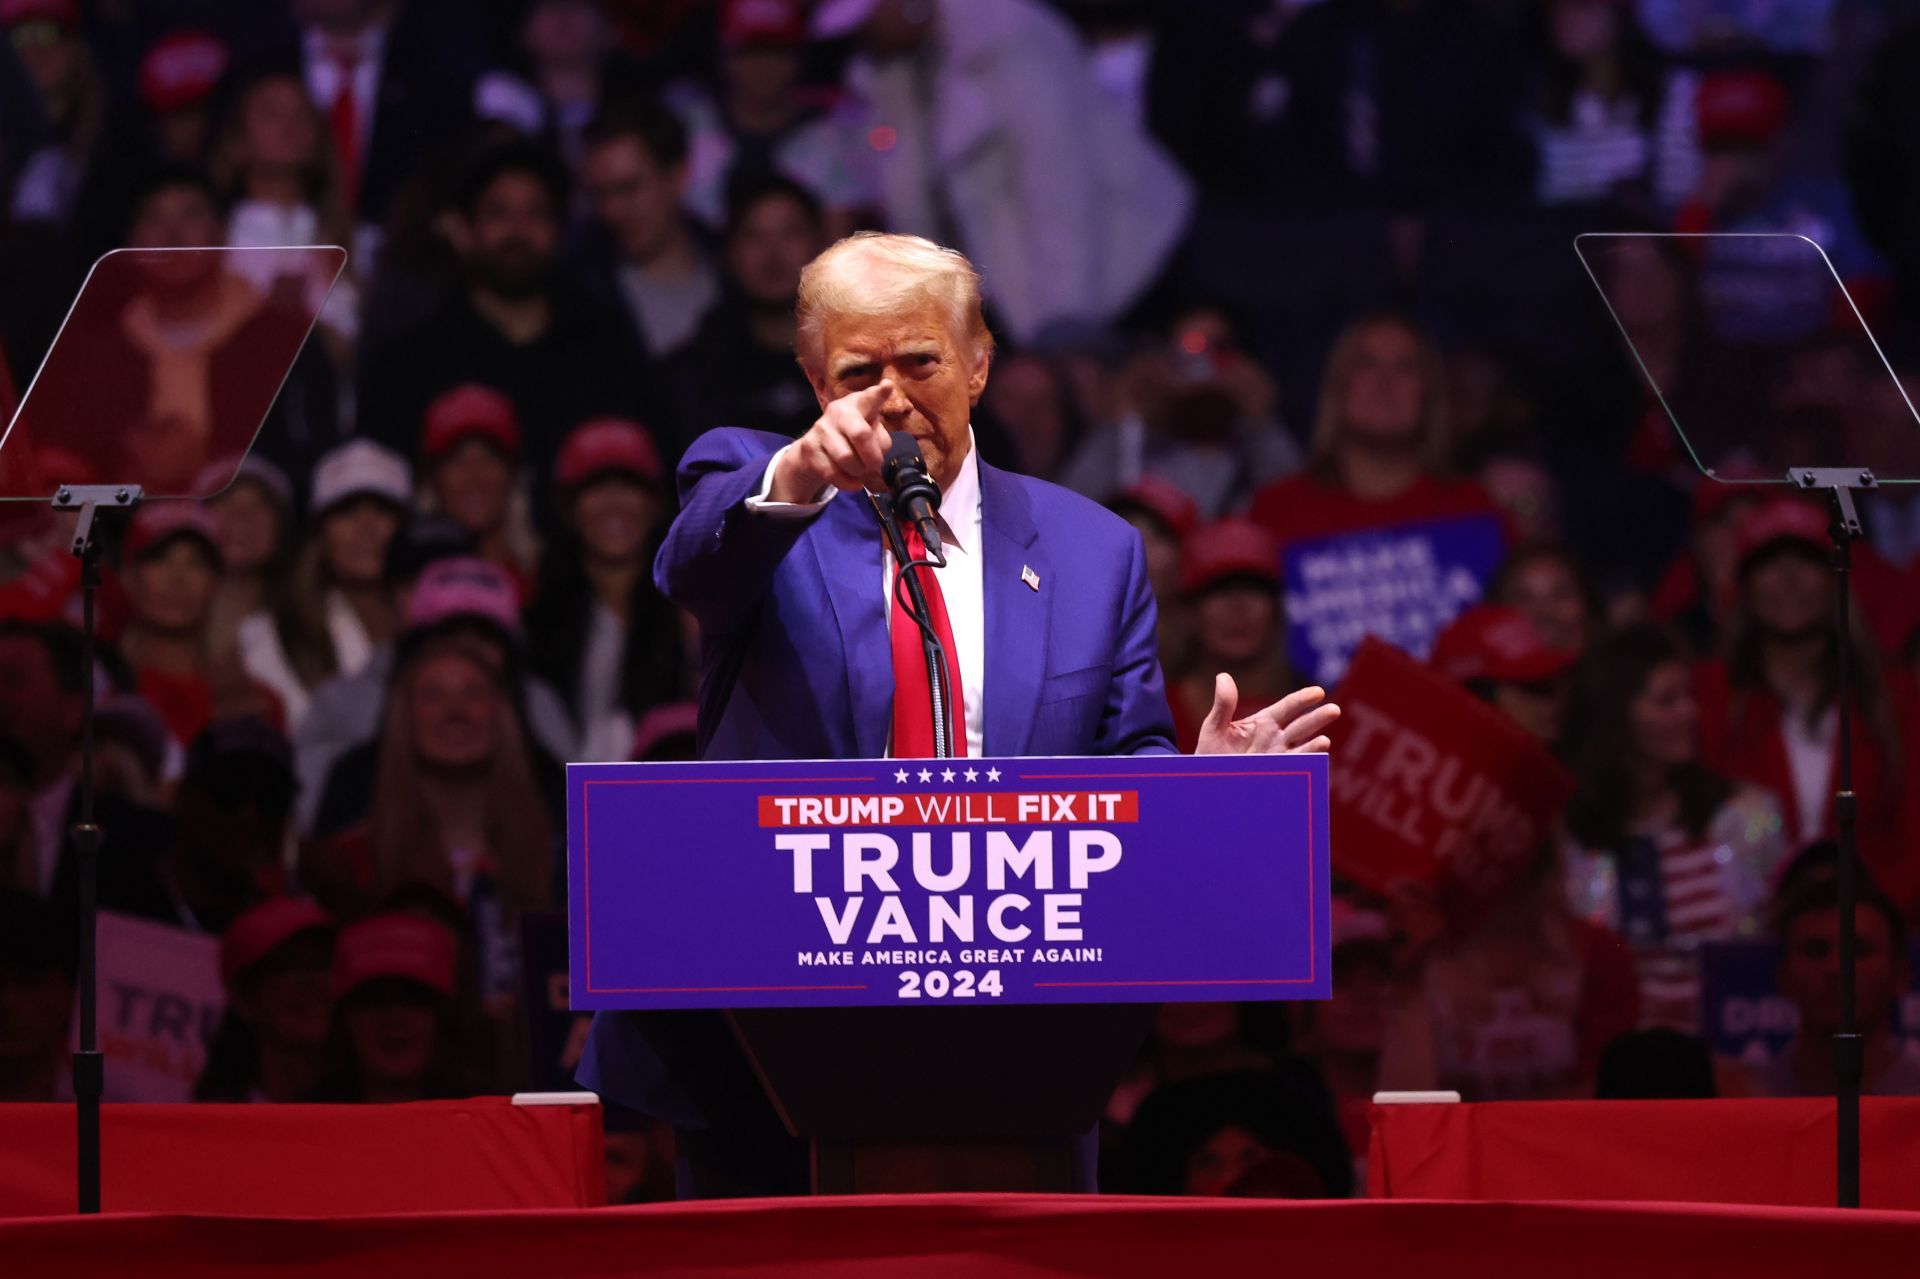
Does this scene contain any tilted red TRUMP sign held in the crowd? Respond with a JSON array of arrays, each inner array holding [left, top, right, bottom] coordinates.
[[1329, 636, 1574, 901]]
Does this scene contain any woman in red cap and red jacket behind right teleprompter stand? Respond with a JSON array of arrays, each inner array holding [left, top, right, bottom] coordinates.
[[1697, 495, 1920, 914]]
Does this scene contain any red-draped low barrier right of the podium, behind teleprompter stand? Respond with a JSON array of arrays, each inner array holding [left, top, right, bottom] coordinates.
[[1367, 1097, 1920, 1206]]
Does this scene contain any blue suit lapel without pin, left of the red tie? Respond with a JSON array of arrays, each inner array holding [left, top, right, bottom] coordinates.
[[808, 494, 893, 759]]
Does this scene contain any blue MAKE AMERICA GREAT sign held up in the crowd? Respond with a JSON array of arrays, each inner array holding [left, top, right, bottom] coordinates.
[[1281, 515, 1507, 686]]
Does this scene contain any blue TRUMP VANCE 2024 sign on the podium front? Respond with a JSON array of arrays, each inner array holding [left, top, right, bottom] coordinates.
[[566, 755, 1331, 1008]]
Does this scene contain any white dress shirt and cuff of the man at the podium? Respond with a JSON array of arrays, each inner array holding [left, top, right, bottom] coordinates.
[[747, 426, 987, 759]]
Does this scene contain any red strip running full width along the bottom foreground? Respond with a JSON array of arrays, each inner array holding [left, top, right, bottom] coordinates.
[[0, 1195, 1920, 1279]]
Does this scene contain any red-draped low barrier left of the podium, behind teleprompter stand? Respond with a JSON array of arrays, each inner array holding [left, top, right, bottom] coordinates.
[[0, 1097, 607, 1213]]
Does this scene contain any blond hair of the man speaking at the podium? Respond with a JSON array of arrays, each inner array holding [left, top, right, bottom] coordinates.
[[795, 230, 993, 378]]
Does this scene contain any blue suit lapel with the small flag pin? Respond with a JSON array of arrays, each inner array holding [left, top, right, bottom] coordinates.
[[979, 463, 1052, 755]]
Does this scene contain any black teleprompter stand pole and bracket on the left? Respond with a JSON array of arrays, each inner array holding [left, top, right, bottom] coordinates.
[[54, 484, 142, 1214]]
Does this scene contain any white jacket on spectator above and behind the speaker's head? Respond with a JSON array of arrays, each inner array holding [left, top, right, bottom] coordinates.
[[849, 0, 1192, 342]]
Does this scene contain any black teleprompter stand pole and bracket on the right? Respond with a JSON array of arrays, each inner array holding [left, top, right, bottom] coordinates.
[[1788, 467, 1878, 1208]]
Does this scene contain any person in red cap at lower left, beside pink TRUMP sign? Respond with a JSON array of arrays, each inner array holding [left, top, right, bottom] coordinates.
[[194, 897, 334, 1102]]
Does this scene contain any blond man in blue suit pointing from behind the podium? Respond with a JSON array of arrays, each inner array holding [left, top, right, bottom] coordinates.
[[580, 232, 1338, 1193]]
